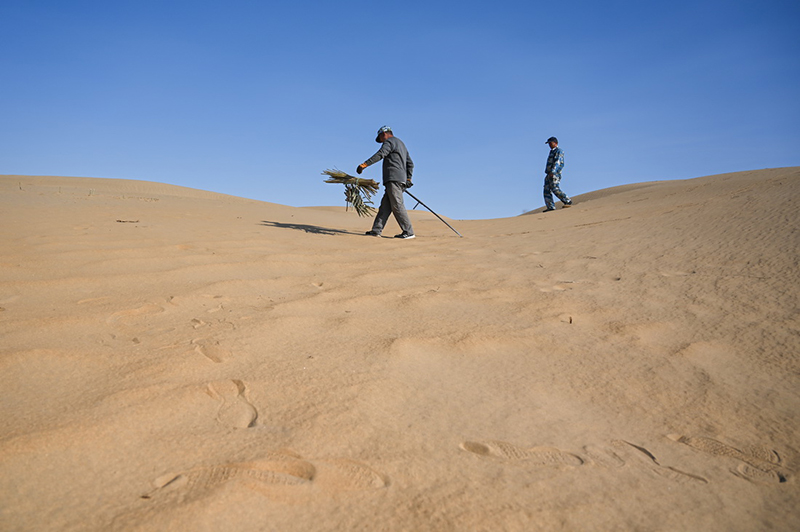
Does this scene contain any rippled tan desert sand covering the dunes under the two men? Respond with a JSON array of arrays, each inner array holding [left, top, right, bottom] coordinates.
[[0, 168, 800, 531]]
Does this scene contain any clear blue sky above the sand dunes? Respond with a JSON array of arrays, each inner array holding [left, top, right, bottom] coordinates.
[[0, 0, 800, 219]]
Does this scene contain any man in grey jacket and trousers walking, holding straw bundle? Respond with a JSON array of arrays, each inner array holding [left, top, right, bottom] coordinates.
[[356, 126, 414, 239]]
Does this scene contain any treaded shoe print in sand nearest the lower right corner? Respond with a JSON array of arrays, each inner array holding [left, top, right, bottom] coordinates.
[[667, 434, 788, 484]]
